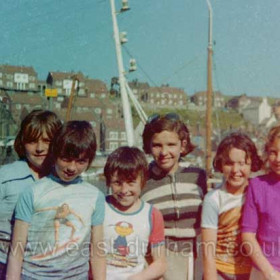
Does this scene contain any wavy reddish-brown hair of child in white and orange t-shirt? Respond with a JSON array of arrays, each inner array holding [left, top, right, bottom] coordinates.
[[213, 132, 262, 173]]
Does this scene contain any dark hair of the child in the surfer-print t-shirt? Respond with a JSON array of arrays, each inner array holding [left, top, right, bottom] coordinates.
[[52, 121, 96, 167]]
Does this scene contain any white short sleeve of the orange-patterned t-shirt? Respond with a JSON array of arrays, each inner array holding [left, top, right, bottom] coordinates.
[[201, 192, 219, 229]]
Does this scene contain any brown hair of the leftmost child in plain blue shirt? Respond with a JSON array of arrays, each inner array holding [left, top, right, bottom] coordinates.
[[14, 110, 61, 159]]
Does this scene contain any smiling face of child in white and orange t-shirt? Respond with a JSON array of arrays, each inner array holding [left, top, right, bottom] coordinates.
[[222, 148, 251, 194]]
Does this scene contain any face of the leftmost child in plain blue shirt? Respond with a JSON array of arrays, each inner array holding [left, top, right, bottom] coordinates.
[[24, 132, 50, 172]]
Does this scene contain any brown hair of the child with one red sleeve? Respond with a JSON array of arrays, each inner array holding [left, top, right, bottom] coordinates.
[[104, 146, 148, 188]]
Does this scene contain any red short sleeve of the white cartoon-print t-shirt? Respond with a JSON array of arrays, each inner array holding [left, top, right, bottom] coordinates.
[[149, 207, 164, 247]]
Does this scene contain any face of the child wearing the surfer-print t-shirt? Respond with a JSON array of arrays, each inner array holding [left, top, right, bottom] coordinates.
[[55, 155, 89, 182]]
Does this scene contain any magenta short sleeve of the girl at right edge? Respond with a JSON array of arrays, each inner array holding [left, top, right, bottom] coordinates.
[[241, 181, 259, 233]]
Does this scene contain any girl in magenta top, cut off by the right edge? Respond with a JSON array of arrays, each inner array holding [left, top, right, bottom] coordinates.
[[242, 126, 280, 280]]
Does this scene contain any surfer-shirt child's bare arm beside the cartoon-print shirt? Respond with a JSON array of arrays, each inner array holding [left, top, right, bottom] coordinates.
[[90, 225, 106, 280]]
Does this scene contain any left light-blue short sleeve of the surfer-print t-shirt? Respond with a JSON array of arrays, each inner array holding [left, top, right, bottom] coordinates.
[[15, 188, 34, 224]]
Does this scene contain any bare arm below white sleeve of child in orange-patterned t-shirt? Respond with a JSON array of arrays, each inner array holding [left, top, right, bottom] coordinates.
[[202, 228, 218, 280]]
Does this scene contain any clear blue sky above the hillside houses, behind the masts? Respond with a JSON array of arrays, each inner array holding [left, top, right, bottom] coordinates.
[[0, 0, 280, 97]]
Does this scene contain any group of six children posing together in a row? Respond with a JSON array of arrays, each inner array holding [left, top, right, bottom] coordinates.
[[0, 110, 280, 280]]
